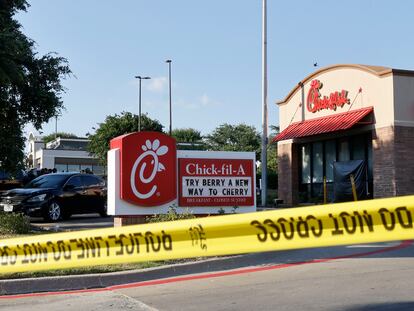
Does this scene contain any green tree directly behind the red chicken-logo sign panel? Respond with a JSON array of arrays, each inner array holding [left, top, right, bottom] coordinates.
[[88, 112, 163, 165]]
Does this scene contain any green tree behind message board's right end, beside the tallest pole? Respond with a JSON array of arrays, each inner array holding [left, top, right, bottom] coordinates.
[[206, 123, 260, 156]]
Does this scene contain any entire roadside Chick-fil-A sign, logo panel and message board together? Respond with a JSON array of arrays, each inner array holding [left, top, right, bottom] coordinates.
[[108, 132, 256, 223]]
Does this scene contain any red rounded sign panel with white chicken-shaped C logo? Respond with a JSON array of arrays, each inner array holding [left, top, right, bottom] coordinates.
[[111, 132, 177, 207]]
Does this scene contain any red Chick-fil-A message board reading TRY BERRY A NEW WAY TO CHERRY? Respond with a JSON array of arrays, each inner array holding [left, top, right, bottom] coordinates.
[[179, 158, 255, 206]]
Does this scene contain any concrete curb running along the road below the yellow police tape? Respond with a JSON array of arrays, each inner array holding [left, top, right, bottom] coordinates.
[[0, 244, 402, 295]]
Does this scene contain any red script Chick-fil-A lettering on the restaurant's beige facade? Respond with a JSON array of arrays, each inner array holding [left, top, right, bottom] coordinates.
[[306, 80, 350, 112]]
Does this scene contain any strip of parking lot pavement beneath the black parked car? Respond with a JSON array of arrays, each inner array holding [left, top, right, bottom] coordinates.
[[30, 214, 114, 232]]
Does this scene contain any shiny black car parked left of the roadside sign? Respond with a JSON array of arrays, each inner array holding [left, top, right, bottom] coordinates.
[[0, 173, 107, 221]]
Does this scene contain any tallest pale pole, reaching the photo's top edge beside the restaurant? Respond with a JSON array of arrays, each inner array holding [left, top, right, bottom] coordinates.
[[261, 0, 267, 206]]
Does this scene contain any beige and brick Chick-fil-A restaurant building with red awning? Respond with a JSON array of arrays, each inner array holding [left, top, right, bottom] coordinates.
[[274, 64, 414, 205]]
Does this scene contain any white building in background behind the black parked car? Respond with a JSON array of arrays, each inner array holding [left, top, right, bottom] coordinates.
[[28, 133, 105, 175]]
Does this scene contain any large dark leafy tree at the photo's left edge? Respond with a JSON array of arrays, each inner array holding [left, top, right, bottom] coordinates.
[[0, 0, 70, 172]]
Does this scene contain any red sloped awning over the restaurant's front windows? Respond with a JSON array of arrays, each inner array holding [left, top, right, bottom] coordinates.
[[273, 107, 374, 142]]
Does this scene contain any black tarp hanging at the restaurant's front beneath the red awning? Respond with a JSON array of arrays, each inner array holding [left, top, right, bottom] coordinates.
[[333, 160, 367, 202]]
